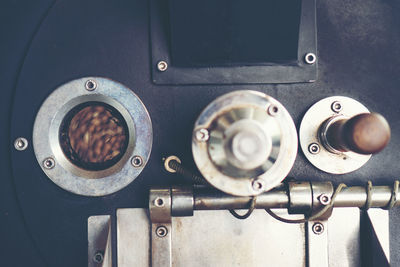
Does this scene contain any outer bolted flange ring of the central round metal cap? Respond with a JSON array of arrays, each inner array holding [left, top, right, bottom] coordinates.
[[192, 90, 297, 196]]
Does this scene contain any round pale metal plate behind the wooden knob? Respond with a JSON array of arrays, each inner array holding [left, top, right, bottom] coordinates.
[[299, 96, 371, 174]]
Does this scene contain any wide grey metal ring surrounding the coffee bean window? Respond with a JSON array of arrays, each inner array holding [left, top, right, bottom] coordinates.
[[33, 77, 153, 196]]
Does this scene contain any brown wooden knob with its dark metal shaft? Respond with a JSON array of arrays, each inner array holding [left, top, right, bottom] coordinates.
[[326, 113, 390, 154]]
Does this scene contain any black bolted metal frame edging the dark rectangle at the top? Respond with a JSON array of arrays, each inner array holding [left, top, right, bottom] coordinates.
[[150, 0, 317, 85]]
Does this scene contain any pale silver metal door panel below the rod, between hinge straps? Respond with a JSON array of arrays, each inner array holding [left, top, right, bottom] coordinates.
[[117, 208, 360, 267]]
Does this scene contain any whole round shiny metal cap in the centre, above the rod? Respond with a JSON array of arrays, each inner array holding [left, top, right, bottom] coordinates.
[[192, 91, 297, 196]]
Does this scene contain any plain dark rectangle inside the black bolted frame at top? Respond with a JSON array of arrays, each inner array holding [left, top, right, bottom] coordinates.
[[164, 0, 302, 67]]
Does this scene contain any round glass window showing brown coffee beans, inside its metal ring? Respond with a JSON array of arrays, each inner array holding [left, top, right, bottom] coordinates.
[[59, 102, 129, 171]]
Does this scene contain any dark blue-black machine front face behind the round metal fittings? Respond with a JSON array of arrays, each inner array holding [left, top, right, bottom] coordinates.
[[0, 0, 400, 266]]
